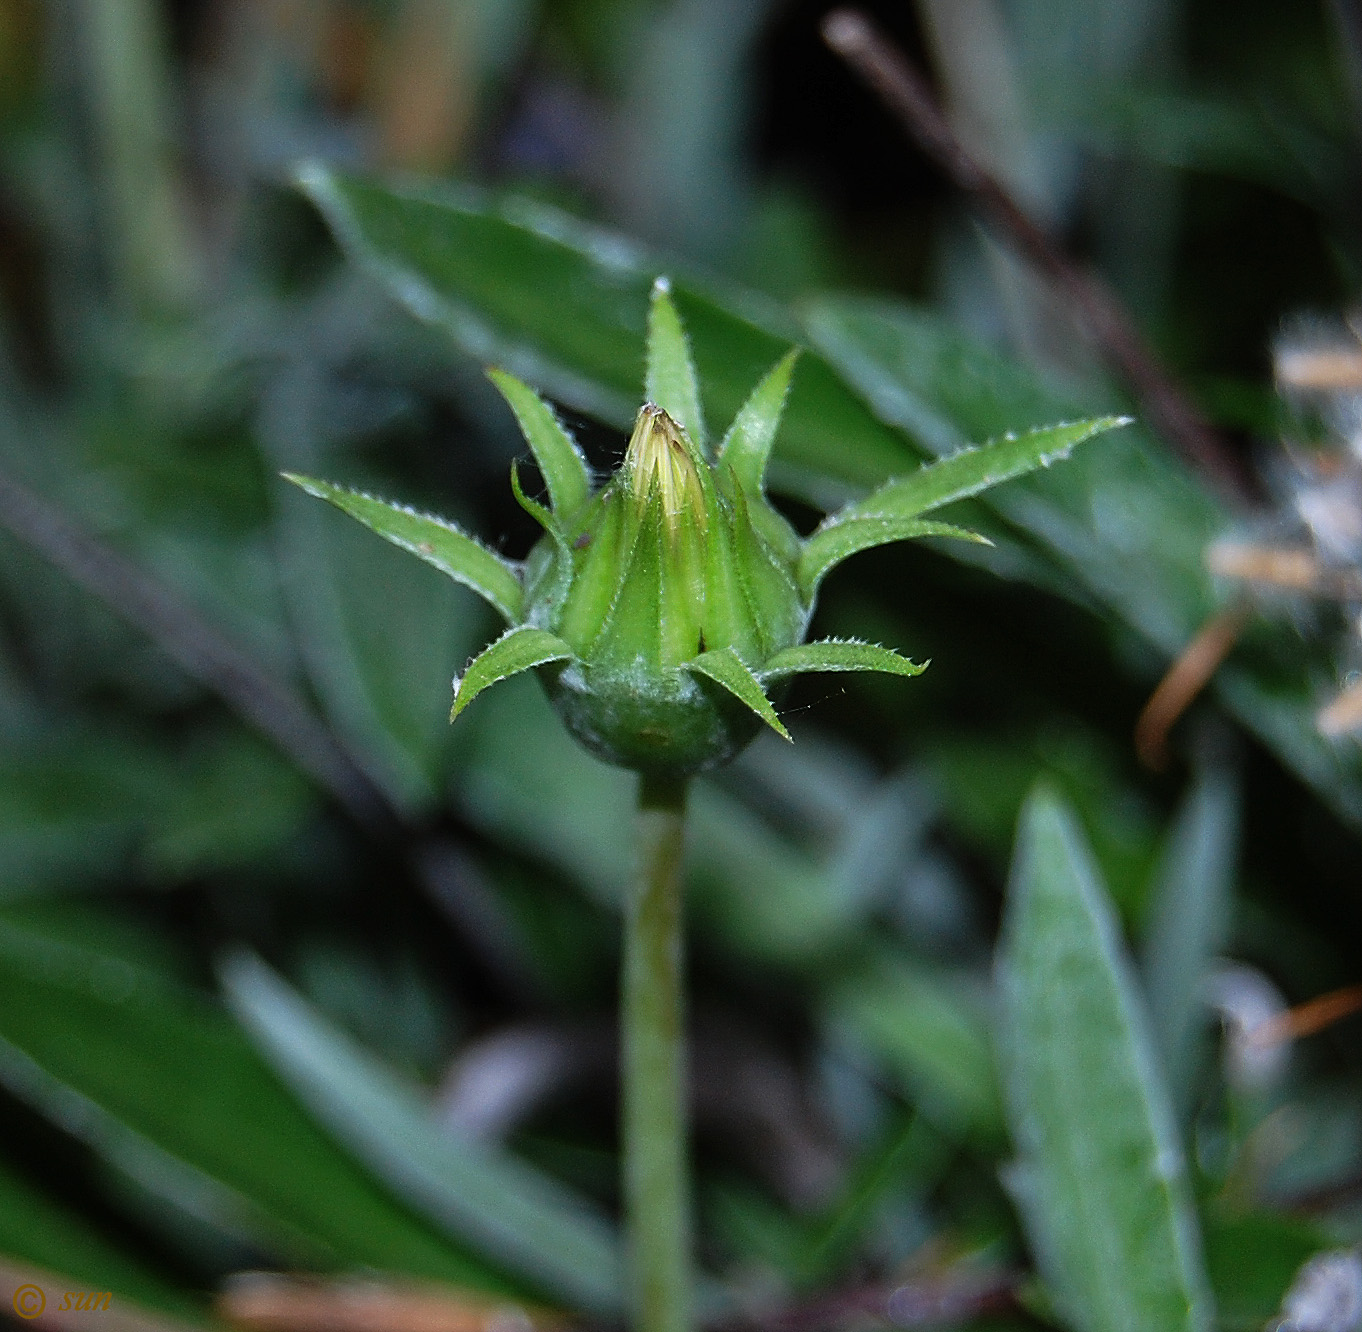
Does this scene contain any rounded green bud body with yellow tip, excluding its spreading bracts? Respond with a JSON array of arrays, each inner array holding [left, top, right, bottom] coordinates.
[[526, 403, 809, 774]]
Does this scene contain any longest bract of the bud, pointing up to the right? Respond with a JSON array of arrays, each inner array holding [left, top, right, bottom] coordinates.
[[838, 417, 1130, 519]]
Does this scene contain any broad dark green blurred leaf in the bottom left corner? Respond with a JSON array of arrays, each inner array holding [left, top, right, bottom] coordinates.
[[0, 923, 513, 1291]]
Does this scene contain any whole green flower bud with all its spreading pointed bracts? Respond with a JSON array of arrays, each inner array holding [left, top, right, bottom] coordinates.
[[281, 281, 1125, 779]]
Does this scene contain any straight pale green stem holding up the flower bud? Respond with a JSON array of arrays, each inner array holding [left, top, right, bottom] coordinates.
[[622, 778, 691, 1332]]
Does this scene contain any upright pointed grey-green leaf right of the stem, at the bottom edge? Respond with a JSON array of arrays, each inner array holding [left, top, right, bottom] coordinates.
[[998, 791, 1212, 1332]]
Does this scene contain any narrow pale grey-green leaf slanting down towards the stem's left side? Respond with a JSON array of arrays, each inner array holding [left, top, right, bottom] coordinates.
[[222, 953, 622, 1316]]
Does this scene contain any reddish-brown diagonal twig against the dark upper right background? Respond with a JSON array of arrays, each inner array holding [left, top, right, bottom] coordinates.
[[823, 10, 1252, 507]]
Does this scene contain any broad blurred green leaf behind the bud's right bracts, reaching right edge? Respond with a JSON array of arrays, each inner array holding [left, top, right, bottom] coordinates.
[[795, 297, 1362, 828]]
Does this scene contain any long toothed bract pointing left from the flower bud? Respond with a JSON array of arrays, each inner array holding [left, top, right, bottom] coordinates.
[[283, 471, 524, 624]]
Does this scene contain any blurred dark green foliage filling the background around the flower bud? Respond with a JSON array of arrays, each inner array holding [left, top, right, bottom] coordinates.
[[0, 0, 1362, 1332]]
